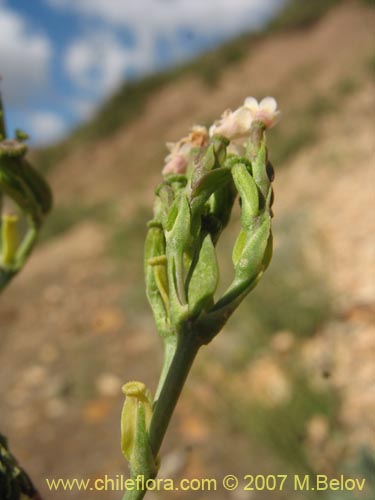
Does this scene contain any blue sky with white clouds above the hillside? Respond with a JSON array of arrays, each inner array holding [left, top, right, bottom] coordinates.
[[0, 0, 285, 145]]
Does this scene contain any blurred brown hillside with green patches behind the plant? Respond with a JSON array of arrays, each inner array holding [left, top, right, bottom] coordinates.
[[0, 0, 375, 500]]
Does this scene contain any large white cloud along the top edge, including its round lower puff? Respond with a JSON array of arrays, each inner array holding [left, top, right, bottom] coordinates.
[[50, 0, 284, 95]]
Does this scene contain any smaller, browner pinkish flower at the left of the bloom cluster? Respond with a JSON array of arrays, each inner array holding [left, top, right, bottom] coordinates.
[[162, 125, 208, 175]]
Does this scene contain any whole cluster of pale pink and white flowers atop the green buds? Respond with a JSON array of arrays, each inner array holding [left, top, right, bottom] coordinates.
[[163, 97, 280, 175]]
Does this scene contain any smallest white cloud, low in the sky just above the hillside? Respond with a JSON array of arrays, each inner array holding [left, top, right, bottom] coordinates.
[[26, 111, 67, 146]]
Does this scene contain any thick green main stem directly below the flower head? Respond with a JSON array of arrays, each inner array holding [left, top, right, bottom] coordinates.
[[123, 330, 201, 500]]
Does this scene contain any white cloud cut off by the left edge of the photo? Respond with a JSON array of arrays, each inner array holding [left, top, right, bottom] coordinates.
[[0, 3, 52, 106]]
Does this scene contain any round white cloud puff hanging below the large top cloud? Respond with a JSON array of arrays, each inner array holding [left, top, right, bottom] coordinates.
[[64, 34, 136, 95]]
